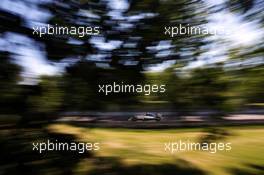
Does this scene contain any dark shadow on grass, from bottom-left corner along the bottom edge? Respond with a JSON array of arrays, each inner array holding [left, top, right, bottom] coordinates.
[[0, 124, 205, 175]]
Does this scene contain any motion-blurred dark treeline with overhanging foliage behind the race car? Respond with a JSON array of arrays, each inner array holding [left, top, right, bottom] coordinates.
[[0, 0, 264, 121]]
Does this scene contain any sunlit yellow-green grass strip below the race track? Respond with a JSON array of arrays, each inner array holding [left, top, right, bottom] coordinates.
[[48, 124, 264, 175]]
